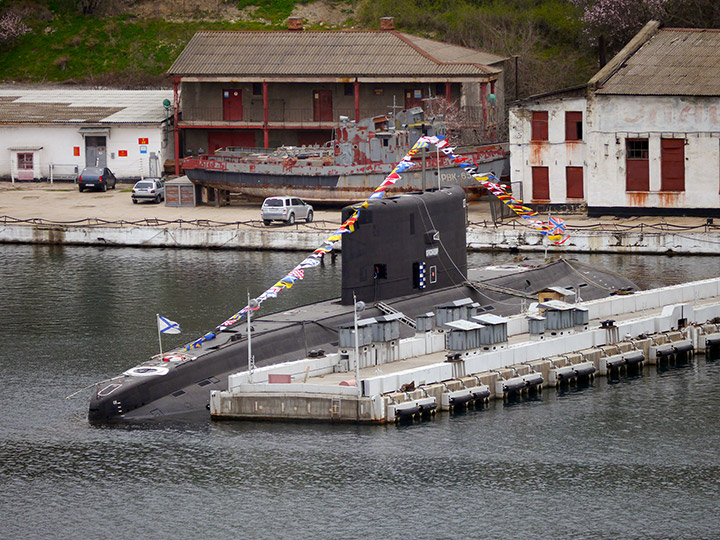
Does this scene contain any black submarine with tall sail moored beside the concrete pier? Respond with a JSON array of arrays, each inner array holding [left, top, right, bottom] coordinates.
[[88, 186, 637, 423]]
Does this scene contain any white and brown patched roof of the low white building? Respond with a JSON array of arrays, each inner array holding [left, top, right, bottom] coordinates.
[[0, 86, 173, 124]]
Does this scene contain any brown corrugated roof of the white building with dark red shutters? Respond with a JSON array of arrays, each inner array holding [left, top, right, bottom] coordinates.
[[597, 28, 720, 96]]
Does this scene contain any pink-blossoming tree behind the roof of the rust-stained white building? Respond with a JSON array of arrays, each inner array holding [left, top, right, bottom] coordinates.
[[570, 0, 671, 65]]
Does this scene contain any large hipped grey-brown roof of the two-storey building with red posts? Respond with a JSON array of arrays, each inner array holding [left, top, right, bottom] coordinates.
[[168, 31, 499, 77]]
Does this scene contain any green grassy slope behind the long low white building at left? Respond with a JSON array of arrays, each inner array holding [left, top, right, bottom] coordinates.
[[0, 0, 306, 86]]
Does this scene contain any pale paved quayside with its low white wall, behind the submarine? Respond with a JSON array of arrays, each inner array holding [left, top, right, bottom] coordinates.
[[0, 183, 720, 255]]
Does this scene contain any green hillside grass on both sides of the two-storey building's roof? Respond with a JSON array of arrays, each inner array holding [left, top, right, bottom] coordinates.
[[0, 0, 594, 93]]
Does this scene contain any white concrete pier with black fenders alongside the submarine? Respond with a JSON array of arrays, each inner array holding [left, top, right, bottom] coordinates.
[[210, 278, 720, 423]]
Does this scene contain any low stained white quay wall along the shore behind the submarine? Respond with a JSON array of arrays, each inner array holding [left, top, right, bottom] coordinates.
[[0, 223, 720, 255]]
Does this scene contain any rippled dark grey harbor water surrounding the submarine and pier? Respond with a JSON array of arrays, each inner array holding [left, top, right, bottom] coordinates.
[[0, 245, 720, 540]]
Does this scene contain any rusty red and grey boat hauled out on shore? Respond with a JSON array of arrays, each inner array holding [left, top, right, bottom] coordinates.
[[182, 108, 509, 206]]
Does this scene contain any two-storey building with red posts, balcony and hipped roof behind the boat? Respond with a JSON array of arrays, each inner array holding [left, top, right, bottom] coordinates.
[[168, 19, 506, 173]]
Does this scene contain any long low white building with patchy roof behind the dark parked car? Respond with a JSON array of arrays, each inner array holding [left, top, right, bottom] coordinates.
[[0, 86, 174, 181]]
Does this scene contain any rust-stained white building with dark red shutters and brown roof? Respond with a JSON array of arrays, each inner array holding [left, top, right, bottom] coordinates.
[[510, 21, 720, 217]]
